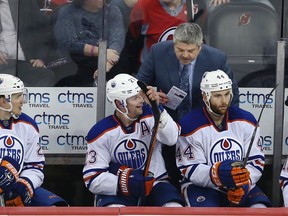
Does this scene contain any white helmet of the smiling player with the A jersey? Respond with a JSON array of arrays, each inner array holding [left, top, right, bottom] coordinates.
[[106, 73, 141, 115]]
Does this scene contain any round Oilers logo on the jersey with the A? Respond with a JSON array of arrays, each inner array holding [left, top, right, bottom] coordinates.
[[114, 139, 148, 169]]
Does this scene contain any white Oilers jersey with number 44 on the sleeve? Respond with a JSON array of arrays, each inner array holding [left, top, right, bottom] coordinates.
[[176, 106, 265, 189]]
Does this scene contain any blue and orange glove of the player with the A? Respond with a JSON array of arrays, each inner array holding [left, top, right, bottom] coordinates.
[[118, 168, 155, 197]]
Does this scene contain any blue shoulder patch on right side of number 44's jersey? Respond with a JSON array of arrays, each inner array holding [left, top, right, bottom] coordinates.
[[229, 106, 257, 125]]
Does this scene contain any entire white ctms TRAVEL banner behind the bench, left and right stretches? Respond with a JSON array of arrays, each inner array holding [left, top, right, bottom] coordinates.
[[23, 87, 288, 155]]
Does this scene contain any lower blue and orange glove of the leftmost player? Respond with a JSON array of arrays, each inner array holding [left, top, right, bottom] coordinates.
[[5, 178, 34, 206]]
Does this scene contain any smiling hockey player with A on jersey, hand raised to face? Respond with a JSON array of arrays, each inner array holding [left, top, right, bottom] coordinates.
[[83, 74, 183, 207]]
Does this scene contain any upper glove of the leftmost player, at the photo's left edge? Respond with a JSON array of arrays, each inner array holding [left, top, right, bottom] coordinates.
[[0, 156, 20, 193]]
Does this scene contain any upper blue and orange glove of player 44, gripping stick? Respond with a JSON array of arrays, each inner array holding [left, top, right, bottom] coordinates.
[[210, 160, 250, 189]]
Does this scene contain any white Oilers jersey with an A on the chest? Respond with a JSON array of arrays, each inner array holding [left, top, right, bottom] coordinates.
[[83, 105, 180, 195]]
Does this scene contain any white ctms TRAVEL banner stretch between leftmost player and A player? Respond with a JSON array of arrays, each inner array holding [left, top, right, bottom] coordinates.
[[23, 87, 113, 154]]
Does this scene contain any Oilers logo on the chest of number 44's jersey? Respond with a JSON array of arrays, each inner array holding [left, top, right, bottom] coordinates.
[[210, 137, 244, 164]]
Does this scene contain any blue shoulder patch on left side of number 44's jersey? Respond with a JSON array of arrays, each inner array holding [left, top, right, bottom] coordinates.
[[180, 107, 210, 136]]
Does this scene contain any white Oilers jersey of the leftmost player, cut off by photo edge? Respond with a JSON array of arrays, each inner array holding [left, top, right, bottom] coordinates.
[[0, 113, 45, 188]]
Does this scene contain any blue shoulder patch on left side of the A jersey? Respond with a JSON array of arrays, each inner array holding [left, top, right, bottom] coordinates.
[[85, 115, 120, 142]]
